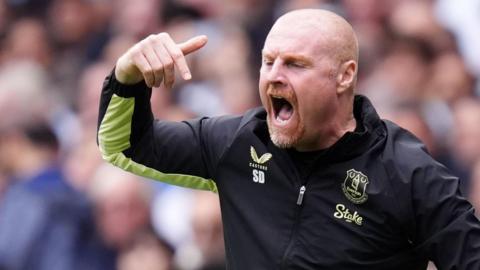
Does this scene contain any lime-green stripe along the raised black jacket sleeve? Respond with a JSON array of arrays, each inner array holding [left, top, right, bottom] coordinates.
[[98, 94, 217, 193]]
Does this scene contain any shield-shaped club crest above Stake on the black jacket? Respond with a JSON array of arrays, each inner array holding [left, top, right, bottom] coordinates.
[[342, 169, 369, 204]]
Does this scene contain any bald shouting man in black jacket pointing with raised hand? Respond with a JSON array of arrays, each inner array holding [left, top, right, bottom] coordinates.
[[98, 10, 480, 269]]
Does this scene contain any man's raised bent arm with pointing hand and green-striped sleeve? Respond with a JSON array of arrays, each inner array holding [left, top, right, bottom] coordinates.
[[98, 33, 235, 191]]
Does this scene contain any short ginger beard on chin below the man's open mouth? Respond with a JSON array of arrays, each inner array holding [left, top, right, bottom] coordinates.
[[267, 118, 305, 149]]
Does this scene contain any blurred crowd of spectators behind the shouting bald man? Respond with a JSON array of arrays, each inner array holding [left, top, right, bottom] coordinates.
[[0, 0, 480, 270]]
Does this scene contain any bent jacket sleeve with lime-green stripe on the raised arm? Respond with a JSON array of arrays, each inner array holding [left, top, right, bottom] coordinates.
[[97, 69, 240, 192]]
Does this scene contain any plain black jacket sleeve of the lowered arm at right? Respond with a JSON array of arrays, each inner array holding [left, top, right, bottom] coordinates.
[[411, 149, 480, 270]]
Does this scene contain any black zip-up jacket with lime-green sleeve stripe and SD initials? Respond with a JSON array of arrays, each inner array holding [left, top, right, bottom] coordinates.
[[98, 72, 480, 270]]
